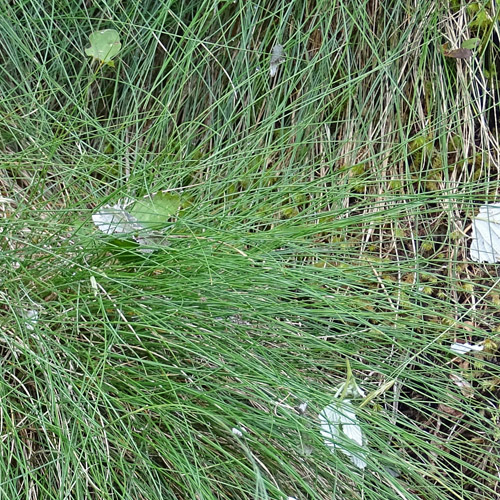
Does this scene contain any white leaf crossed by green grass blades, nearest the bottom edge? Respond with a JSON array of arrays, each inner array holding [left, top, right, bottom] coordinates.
[[319, 399, 366, 469]]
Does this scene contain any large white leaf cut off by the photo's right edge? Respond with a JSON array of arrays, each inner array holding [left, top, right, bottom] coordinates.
[[470, 204, 500, 263]]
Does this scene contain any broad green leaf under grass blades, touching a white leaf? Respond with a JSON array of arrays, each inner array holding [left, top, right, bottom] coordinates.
[[131, 193, 181, 229]]
